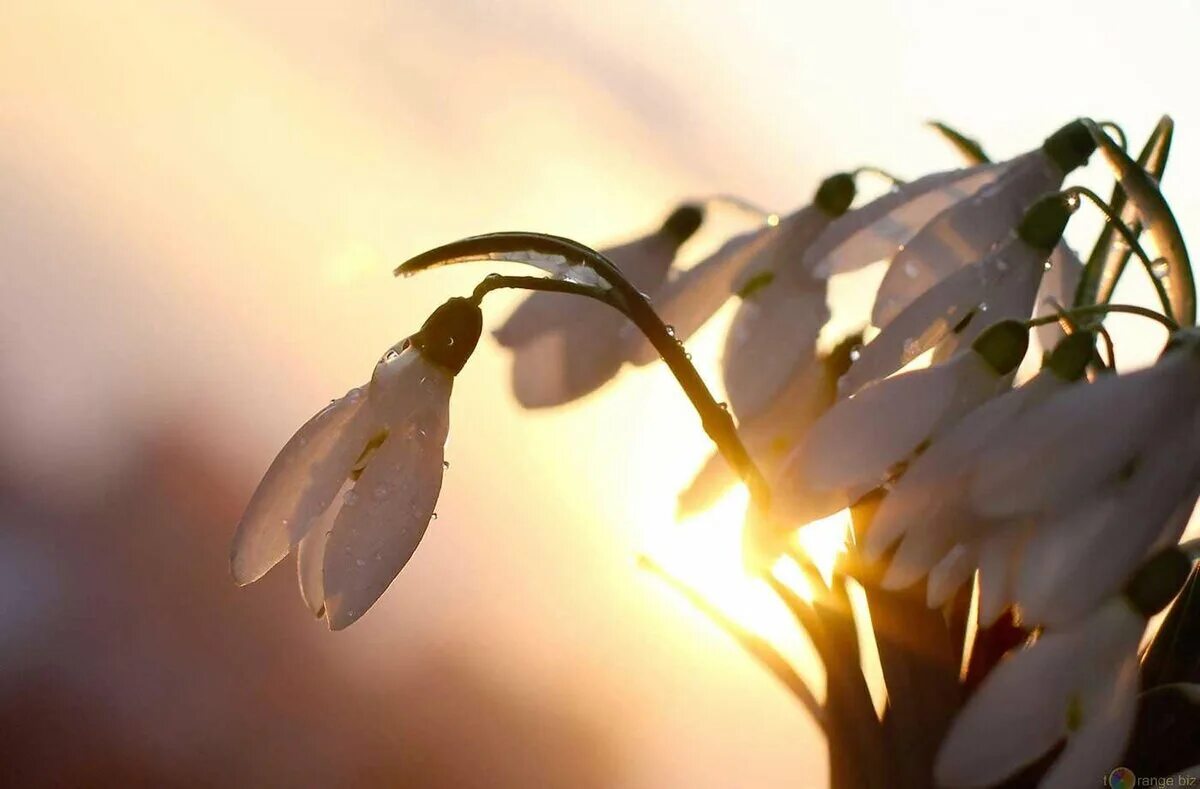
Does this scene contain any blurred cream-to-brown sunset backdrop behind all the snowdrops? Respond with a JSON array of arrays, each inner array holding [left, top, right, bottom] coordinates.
[[0, 0, 1200, 789]]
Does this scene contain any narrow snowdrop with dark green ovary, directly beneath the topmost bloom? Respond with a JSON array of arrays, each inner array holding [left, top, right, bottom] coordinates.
[[839, 194, 1070, 393]]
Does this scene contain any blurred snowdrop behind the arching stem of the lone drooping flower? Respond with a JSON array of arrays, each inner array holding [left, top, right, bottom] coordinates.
[[493, 205, 703, 408]]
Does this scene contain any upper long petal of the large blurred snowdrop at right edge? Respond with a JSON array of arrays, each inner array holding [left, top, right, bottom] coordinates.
[[971, 353, 1195, 518]]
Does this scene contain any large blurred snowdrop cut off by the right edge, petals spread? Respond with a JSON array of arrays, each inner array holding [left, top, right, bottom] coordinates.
[[970, 339, 1200, 624]]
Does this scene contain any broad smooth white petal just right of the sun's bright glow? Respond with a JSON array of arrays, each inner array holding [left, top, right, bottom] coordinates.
[[798, 351, 1003, 489]]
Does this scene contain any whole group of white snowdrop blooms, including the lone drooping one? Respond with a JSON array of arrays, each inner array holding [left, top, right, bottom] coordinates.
[[233, 120, 1200, 787]]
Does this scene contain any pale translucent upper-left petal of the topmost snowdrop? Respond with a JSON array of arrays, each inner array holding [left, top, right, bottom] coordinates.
[[805, 162, 1009, 277]]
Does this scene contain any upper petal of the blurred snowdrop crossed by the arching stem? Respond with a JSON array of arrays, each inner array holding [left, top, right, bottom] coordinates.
[[492, 233, 674, 348]]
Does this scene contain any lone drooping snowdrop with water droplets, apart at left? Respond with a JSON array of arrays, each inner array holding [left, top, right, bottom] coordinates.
[[232, 299, 482, 630]]
